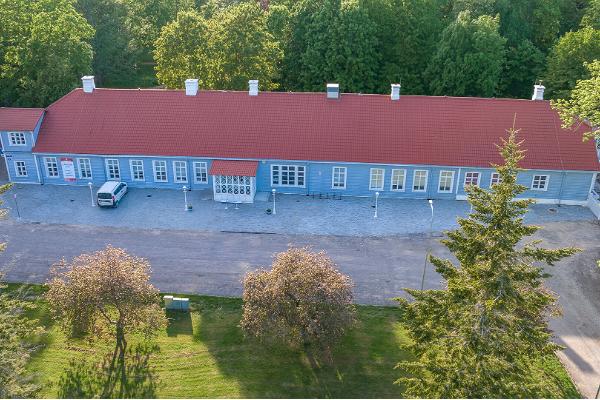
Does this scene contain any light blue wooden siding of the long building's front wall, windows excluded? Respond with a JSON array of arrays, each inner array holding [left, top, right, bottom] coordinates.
[[8, 152, 594, 201]]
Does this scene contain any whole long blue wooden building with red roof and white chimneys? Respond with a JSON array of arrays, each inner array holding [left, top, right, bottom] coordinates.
[[0, 77, 600, 205]]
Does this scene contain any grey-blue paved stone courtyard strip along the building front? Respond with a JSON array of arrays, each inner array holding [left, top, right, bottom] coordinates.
[[4, 185, 594, 236]]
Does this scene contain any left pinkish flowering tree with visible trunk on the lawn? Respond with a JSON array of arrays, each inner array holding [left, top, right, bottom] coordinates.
[[46, 245, 166, 370]]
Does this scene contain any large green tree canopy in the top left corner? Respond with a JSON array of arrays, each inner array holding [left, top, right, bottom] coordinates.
[[0, 0, 94, 107]]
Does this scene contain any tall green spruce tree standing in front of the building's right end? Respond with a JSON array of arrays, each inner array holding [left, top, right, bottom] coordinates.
[[398, 128, 577, 398]]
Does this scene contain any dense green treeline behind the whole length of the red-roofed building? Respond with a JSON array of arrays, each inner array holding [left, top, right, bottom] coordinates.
[[0, 0, 600, 106]]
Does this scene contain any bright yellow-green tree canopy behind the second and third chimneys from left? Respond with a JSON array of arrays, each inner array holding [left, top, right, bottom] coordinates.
[[155, 3, 282, 90]]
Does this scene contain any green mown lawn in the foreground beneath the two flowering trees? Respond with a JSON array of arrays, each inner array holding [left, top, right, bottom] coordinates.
[[15, 287, 579, 398]]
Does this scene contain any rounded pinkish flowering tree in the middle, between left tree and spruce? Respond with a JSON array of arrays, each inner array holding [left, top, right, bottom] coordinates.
[[241, 248, 355, 360]]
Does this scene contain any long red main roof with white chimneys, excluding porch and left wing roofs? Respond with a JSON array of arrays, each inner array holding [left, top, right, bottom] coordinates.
[[34, 89, 600, 171]]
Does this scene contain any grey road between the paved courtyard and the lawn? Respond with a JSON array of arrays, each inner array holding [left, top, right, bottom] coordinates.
[[0, 221, 600, 397]]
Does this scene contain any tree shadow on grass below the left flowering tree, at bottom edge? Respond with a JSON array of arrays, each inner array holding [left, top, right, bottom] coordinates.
[[58, 344, 158, 399]]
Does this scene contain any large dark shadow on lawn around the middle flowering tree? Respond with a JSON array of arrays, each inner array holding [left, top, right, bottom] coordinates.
[[195, 298, 409, 398]]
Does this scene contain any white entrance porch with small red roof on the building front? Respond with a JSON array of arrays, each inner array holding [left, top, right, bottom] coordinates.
[[210, 160, 258, 203]]
